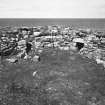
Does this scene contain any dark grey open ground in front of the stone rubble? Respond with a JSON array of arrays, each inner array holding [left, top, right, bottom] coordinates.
[[0, 49, 105, 105]]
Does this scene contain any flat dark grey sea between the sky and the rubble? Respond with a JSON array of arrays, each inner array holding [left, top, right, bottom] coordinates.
[[0, 18, 105, 31]]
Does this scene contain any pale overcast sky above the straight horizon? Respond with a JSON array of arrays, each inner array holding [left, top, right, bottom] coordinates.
[[0, 0, 105, 18]]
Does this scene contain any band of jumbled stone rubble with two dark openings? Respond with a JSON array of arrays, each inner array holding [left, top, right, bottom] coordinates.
[[0, 26, 105, 66]]
